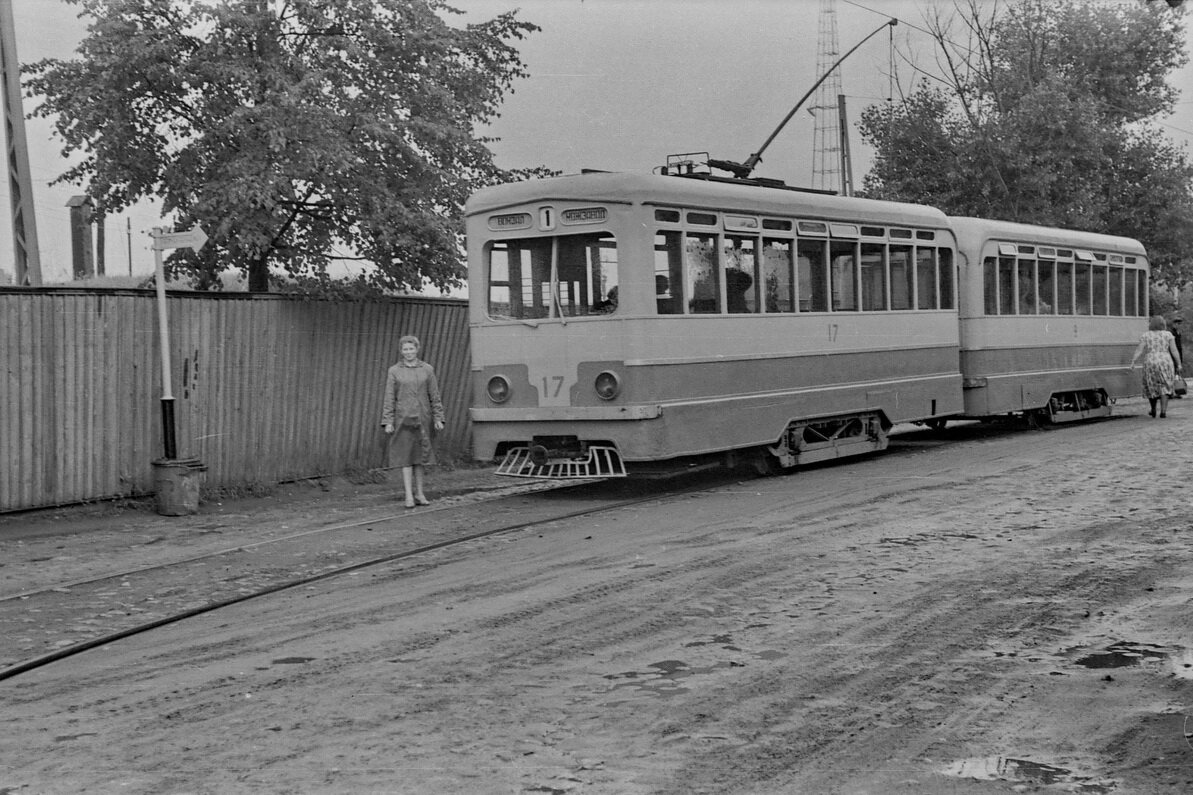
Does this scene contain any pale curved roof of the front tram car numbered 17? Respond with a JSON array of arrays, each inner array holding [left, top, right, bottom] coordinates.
[[465, 172, 948, 227]]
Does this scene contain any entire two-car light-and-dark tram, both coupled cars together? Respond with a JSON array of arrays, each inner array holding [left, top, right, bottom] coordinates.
[[465, 163, 1146, 477]]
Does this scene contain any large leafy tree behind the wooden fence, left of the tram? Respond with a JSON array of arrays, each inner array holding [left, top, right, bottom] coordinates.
[[26, 0, 538, 291]]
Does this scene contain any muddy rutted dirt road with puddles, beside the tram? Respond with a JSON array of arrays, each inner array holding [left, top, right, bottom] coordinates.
[[0, 401, 1193, 795]]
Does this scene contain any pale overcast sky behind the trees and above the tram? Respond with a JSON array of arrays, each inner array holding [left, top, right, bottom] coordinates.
[[7, 0, 1193, 283]]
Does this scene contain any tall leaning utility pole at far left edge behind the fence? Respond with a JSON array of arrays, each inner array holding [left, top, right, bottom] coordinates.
[[0, 0, 42, 286]]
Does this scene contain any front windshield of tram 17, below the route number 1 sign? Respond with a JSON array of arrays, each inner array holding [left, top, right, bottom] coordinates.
[[488, 233, 618, 320]]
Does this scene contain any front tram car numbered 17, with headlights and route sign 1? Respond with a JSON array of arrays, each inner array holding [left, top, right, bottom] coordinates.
[[466, 173, 963, 477]]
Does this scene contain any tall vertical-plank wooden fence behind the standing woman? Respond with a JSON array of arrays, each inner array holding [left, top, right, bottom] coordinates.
[[0, 288, 470, 511]]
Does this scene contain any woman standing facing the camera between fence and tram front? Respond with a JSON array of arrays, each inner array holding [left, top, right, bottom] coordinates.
[[381, 337, 444, 507]]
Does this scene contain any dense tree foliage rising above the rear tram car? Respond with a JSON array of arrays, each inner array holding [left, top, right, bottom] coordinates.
[[860, 0, 1193, 284]]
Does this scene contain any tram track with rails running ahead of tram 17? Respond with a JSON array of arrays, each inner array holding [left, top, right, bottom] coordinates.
[[0, 470, 709, 680]]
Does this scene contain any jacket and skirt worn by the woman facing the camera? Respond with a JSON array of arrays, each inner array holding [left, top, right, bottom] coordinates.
[[381, 360, 444, 467]]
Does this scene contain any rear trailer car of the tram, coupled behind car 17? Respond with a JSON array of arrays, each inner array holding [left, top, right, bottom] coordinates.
[[950, 218, 1148, 423]]
